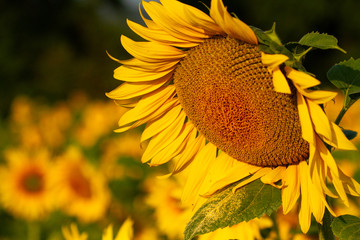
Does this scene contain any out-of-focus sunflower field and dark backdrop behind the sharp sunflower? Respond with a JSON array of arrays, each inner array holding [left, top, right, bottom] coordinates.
[[0, 0, 360, 240]]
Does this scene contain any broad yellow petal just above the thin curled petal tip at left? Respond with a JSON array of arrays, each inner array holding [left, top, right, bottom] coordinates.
[[121, 35, 186, 63]]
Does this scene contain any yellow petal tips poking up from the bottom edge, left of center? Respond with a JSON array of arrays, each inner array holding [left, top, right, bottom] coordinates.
[[62, 218, 134, 240]]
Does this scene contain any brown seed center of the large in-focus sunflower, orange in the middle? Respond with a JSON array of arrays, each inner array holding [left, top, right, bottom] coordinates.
[[174, 37, 309, 167]]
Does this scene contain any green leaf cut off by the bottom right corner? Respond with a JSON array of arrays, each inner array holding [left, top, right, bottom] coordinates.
[[331, 215, 360, 240]]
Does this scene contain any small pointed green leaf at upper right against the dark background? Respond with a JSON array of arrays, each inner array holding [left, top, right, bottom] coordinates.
[[299, 32, 346, 53]]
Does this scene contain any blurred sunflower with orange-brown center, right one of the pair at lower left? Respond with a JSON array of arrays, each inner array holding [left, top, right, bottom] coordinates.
[[54, 147, 110, 222]]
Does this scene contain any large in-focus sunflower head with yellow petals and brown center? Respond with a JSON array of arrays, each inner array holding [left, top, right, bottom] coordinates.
[[107, 0, 360, 232]]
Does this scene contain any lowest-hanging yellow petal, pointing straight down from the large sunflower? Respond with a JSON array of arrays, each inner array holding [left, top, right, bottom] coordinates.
[[298, 161, 311, 233]]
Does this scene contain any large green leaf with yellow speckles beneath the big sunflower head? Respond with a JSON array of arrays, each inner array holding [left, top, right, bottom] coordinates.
[[185, 179, 281, 240]]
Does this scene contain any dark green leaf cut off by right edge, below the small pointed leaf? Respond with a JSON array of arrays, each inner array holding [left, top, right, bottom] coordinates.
[[327, 58, 360, 110]]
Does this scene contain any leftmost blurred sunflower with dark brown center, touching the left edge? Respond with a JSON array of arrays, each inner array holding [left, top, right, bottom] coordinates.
[[0, 149, 54, 221]]
